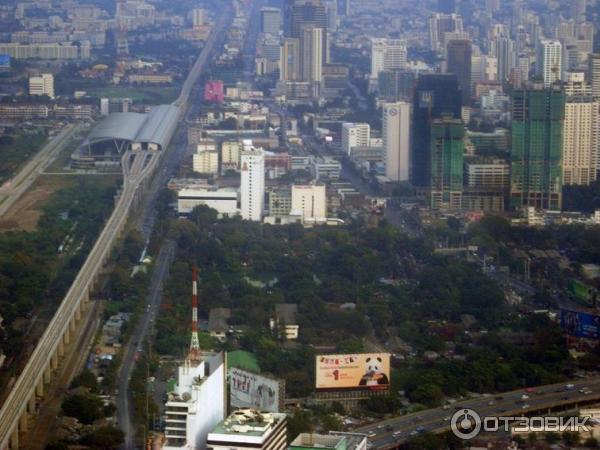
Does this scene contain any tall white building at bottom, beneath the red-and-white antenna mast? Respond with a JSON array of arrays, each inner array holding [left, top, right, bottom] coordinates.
[[162, 353, 227, 450]]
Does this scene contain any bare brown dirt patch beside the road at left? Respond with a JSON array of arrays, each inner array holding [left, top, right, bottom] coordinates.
[[0, 176, 76, 232]]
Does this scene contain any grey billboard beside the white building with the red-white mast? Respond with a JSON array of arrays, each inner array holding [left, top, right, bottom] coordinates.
[[229, 367, 285, 412]]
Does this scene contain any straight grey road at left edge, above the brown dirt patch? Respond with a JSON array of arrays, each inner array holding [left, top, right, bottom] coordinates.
[[0, 124, 80, 217]]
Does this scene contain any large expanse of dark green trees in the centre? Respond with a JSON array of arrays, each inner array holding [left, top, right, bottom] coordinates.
[[156, 207, 573, 408]]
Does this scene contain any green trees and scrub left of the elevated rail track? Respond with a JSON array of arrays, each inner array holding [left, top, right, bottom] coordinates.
[[0, 179, 115, 390]]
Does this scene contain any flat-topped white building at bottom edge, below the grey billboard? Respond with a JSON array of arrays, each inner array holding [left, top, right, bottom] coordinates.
[[208, 409, 287, 450]]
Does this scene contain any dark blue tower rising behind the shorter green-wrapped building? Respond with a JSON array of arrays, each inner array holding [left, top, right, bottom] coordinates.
[[411, 74, 462, 187]]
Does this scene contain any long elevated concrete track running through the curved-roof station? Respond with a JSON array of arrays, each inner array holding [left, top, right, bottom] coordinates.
[[0, 8, 230, 450]]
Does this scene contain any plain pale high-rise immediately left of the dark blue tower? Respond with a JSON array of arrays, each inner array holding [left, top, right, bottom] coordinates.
[[382, 102, 410, 182]]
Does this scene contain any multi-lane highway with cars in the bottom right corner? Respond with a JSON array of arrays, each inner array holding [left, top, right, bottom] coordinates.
[[354, 376, 600, 449]]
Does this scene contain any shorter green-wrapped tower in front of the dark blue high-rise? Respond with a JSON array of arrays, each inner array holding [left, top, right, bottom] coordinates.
[[429, 117, 465, 209]]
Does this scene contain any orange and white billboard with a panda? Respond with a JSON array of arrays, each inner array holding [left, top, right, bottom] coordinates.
[[315, 353, 390, 390]]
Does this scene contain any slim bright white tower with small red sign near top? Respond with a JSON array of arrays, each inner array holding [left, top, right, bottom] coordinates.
[[240, 140, 265, 222]]
